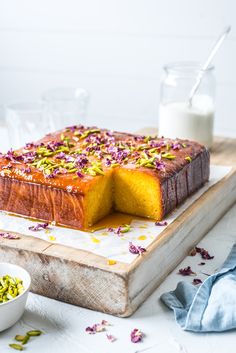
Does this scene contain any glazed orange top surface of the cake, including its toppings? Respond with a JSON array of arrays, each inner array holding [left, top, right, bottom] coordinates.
[[0, 125, 205, 192]]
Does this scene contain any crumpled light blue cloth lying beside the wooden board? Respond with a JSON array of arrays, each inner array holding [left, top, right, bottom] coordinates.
[[161, 244, 236, 332]]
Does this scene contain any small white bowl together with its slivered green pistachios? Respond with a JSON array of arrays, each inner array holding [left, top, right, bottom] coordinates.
[[0, 262, 31, 332]]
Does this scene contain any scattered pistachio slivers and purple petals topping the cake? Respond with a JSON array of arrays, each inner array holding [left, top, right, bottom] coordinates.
[[1, 125, 192, 179]]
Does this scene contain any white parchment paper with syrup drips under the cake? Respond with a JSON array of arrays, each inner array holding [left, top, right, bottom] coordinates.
[[0, 165, 231, 263]]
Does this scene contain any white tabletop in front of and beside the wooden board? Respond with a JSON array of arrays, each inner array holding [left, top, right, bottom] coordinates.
[[0, 205, 236, 353]]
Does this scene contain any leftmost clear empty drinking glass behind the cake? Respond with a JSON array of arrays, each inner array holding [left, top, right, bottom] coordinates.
[[5, 102, 49, 149]]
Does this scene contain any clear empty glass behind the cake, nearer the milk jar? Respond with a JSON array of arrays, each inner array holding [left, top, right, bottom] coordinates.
[[42, 87, 89, 131]]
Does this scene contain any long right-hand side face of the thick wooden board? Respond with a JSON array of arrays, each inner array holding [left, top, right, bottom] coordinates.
[[128, 166, 236, 313]]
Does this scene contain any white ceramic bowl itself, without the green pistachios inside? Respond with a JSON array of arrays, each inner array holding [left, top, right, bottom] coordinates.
[[0, 262, 31, 332]]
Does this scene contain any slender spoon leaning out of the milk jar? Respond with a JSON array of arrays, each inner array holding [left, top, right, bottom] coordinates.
[[188, 26, 231, 107]]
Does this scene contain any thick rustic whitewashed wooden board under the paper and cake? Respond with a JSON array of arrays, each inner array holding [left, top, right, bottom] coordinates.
[[0, 138, 236, 317]]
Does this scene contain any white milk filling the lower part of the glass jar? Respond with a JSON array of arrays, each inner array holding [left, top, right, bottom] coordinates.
[[159, 95, 214, 147]]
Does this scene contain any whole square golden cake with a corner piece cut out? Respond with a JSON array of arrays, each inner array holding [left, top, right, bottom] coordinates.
[[0, 125, 209, 229]]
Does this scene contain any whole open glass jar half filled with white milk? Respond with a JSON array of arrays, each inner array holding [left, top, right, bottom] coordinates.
[[159, 62, 216, 147]]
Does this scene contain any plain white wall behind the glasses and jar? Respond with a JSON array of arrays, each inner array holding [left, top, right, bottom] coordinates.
[[0, 0, 236, 137]]
